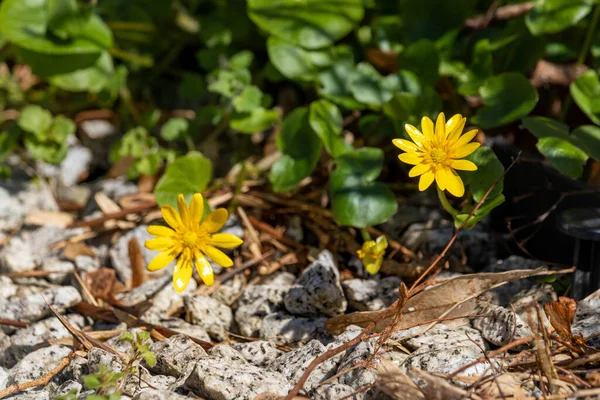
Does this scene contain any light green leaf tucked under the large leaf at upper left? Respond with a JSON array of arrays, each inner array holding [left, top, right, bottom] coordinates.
[[49, 51, 114, 93]]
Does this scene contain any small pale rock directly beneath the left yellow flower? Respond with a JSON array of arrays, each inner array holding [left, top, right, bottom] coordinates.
[[183, 295, 233, 340]]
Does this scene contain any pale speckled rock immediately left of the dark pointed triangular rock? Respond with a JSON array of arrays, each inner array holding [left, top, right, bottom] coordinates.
[[235, 272, 296, 337]]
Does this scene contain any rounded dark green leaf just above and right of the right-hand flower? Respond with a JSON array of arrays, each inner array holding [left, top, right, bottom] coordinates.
[[472, 72, 538, 128]]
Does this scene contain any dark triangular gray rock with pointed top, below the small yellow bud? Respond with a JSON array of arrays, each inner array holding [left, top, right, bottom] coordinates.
[[284, 250, 348, 316]]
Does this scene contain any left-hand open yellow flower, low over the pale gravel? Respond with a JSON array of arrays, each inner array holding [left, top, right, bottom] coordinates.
[[145, 193, 243, 292]]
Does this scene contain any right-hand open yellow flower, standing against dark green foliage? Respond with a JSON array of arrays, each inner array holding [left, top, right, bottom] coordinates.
[[393, 113, 480, 197]]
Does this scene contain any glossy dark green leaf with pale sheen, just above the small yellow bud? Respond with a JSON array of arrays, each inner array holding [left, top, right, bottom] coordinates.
[[330, 147, 398, 228]]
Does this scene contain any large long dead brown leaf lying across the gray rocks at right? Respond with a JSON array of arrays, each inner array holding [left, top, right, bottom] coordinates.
[[325, 268, 573, 334]]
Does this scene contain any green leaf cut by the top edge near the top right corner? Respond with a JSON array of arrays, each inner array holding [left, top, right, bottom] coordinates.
[[525, 0, 596, 36]]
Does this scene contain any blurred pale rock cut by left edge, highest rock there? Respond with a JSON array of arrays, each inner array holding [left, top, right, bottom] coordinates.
[[0, 171, 59, 232]]
